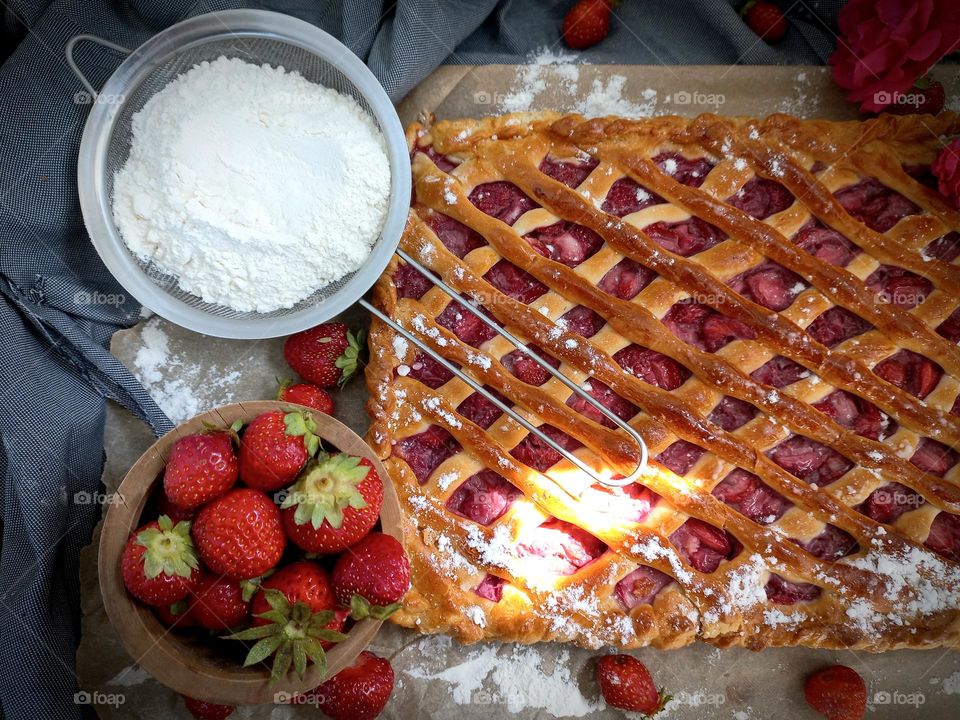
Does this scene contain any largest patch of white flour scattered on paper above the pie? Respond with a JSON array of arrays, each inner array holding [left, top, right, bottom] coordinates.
[[499, 48, 657, 118]]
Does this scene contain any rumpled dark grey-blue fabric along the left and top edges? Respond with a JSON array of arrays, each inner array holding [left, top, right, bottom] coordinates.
[[0, 0, 839, 720]]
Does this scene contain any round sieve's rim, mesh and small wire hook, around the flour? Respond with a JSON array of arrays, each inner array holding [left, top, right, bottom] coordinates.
[[66, 10, 410, 338]]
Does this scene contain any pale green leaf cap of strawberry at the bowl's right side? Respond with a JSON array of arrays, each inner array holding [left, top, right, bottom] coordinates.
[[280, 453, 370, 530]]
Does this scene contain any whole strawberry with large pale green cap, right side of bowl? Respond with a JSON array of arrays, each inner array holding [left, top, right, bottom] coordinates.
[[280, 453, 383, 553]]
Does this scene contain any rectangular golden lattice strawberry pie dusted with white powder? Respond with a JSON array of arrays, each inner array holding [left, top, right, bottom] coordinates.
[[367, 113, 960, 650]]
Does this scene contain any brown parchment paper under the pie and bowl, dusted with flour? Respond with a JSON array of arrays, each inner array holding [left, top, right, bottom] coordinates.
[[77, 65, 960, 720]]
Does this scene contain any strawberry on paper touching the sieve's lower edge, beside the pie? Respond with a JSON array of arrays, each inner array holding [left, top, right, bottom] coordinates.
[[283, 323, 363, 387]]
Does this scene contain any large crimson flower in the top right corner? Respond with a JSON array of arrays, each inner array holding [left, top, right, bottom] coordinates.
[[830, 0, 960, 112]]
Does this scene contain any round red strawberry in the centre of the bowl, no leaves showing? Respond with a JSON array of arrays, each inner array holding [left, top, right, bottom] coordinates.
[[193, 488, 287, 580]]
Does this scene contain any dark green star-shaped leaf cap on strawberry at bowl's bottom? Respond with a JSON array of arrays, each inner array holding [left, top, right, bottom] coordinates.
[[224, 588, 347, 684]]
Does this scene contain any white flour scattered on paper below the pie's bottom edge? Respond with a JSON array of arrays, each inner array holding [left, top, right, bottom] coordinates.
[[406, 645, 603, 717]]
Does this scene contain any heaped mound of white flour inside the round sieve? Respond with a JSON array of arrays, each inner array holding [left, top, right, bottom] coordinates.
[[113, 57, 390, 312]]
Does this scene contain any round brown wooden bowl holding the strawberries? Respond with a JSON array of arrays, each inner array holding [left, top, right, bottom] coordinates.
[[99, 400, 400, 705]]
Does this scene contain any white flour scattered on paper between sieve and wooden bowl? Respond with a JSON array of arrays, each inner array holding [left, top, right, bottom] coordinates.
[[133, 321, 240, 423]]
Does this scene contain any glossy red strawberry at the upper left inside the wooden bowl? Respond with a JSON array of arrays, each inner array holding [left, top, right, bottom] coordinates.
[[163, 430, 239, 510]]
